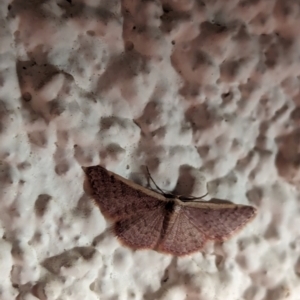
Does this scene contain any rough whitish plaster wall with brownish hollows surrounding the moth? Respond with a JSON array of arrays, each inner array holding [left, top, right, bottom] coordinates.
[[0, 0, 300, 300]]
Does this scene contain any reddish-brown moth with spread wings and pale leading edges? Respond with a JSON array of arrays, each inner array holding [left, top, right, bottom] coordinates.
[[83, 166, 257, 256]]
